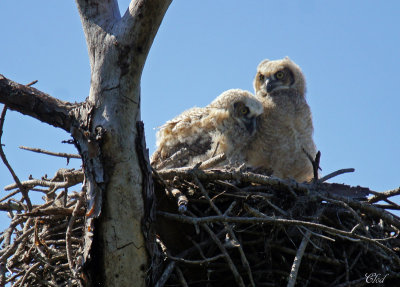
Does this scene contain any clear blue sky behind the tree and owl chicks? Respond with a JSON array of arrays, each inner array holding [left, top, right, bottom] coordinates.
[[0, 0, 400, 230]]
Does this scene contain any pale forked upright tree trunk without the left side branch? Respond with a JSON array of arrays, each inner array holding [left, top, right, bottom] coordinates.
[[77, 0, 171, 286]]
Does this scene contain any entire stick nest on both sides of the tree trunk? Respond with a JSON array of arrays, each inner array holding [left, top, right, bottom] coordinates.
[[0, 151, 400, 286]]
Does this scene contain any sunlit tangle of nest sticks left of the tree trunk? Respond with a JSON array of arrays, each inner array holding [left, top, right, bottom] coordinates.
[[0, 169, 85, 286]]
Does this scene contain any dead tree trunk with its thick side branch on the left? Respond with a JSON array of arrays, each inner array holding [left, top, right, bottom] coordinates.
[[0, 0, 172, 286]]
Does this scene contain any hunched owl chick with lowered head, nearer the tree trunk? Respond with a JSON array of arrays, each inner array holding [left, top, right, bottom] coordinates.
[[151, 89, 263, 167]]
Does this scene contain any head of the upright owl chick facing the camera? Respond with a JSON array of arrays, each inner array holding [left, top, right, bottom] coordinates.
[[253, 57, 306, 97]]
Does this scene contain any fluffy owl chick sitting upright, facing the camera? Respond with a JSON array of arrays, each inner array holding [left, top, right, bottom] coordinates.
[[247, 57, 316, 182]]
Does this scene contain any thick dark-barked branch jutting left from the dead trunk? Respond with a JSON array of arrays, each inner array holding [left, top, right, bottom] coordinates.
[[0, 75, 74, 132]]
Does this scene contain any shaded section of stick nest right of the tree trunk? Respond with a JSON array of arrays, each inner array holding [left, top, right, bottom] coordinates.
[[152, 168, 400, 286]]
